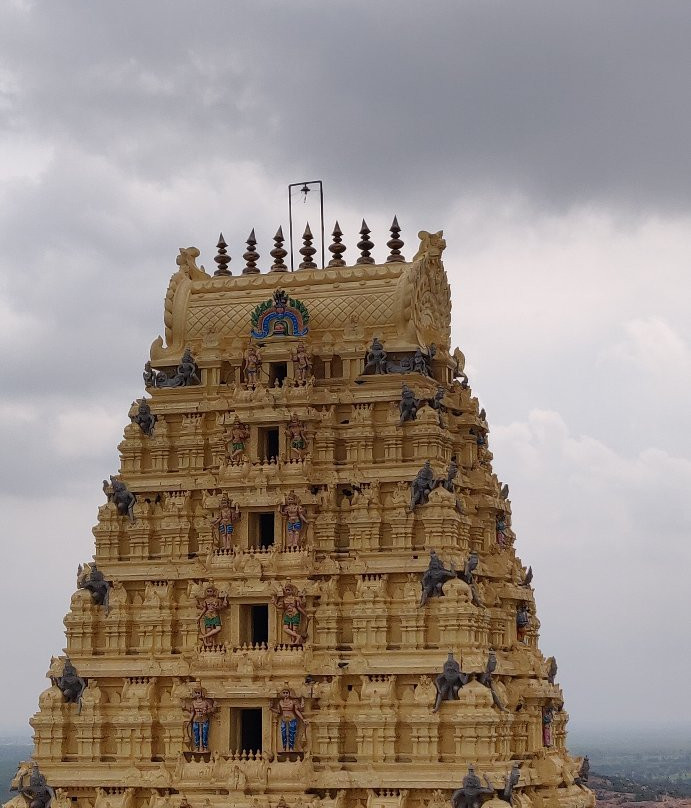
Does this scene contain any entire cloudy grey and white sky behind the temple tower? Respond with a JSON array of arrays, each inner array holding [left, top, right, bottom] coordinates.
[[0, 0, 691, 730]]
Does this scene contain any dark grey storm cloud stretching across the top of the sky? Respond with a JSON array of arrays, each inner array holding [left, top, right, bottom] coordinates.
[[2, 0, 691, 210]]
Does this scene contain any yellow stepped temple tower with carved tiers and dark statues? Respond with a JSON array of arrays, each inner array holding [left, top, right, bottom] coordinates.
[[8, 220, 594, 808]]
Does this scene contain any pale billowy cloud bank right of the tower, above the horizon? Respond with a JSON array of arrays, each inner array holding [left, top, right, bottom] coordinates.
[[492, 411, 691, 727]]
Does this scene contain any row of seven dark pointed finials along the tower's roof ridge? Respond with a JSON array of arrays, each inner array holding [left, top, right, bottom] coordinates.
[[214, 216, 405, 277]]
